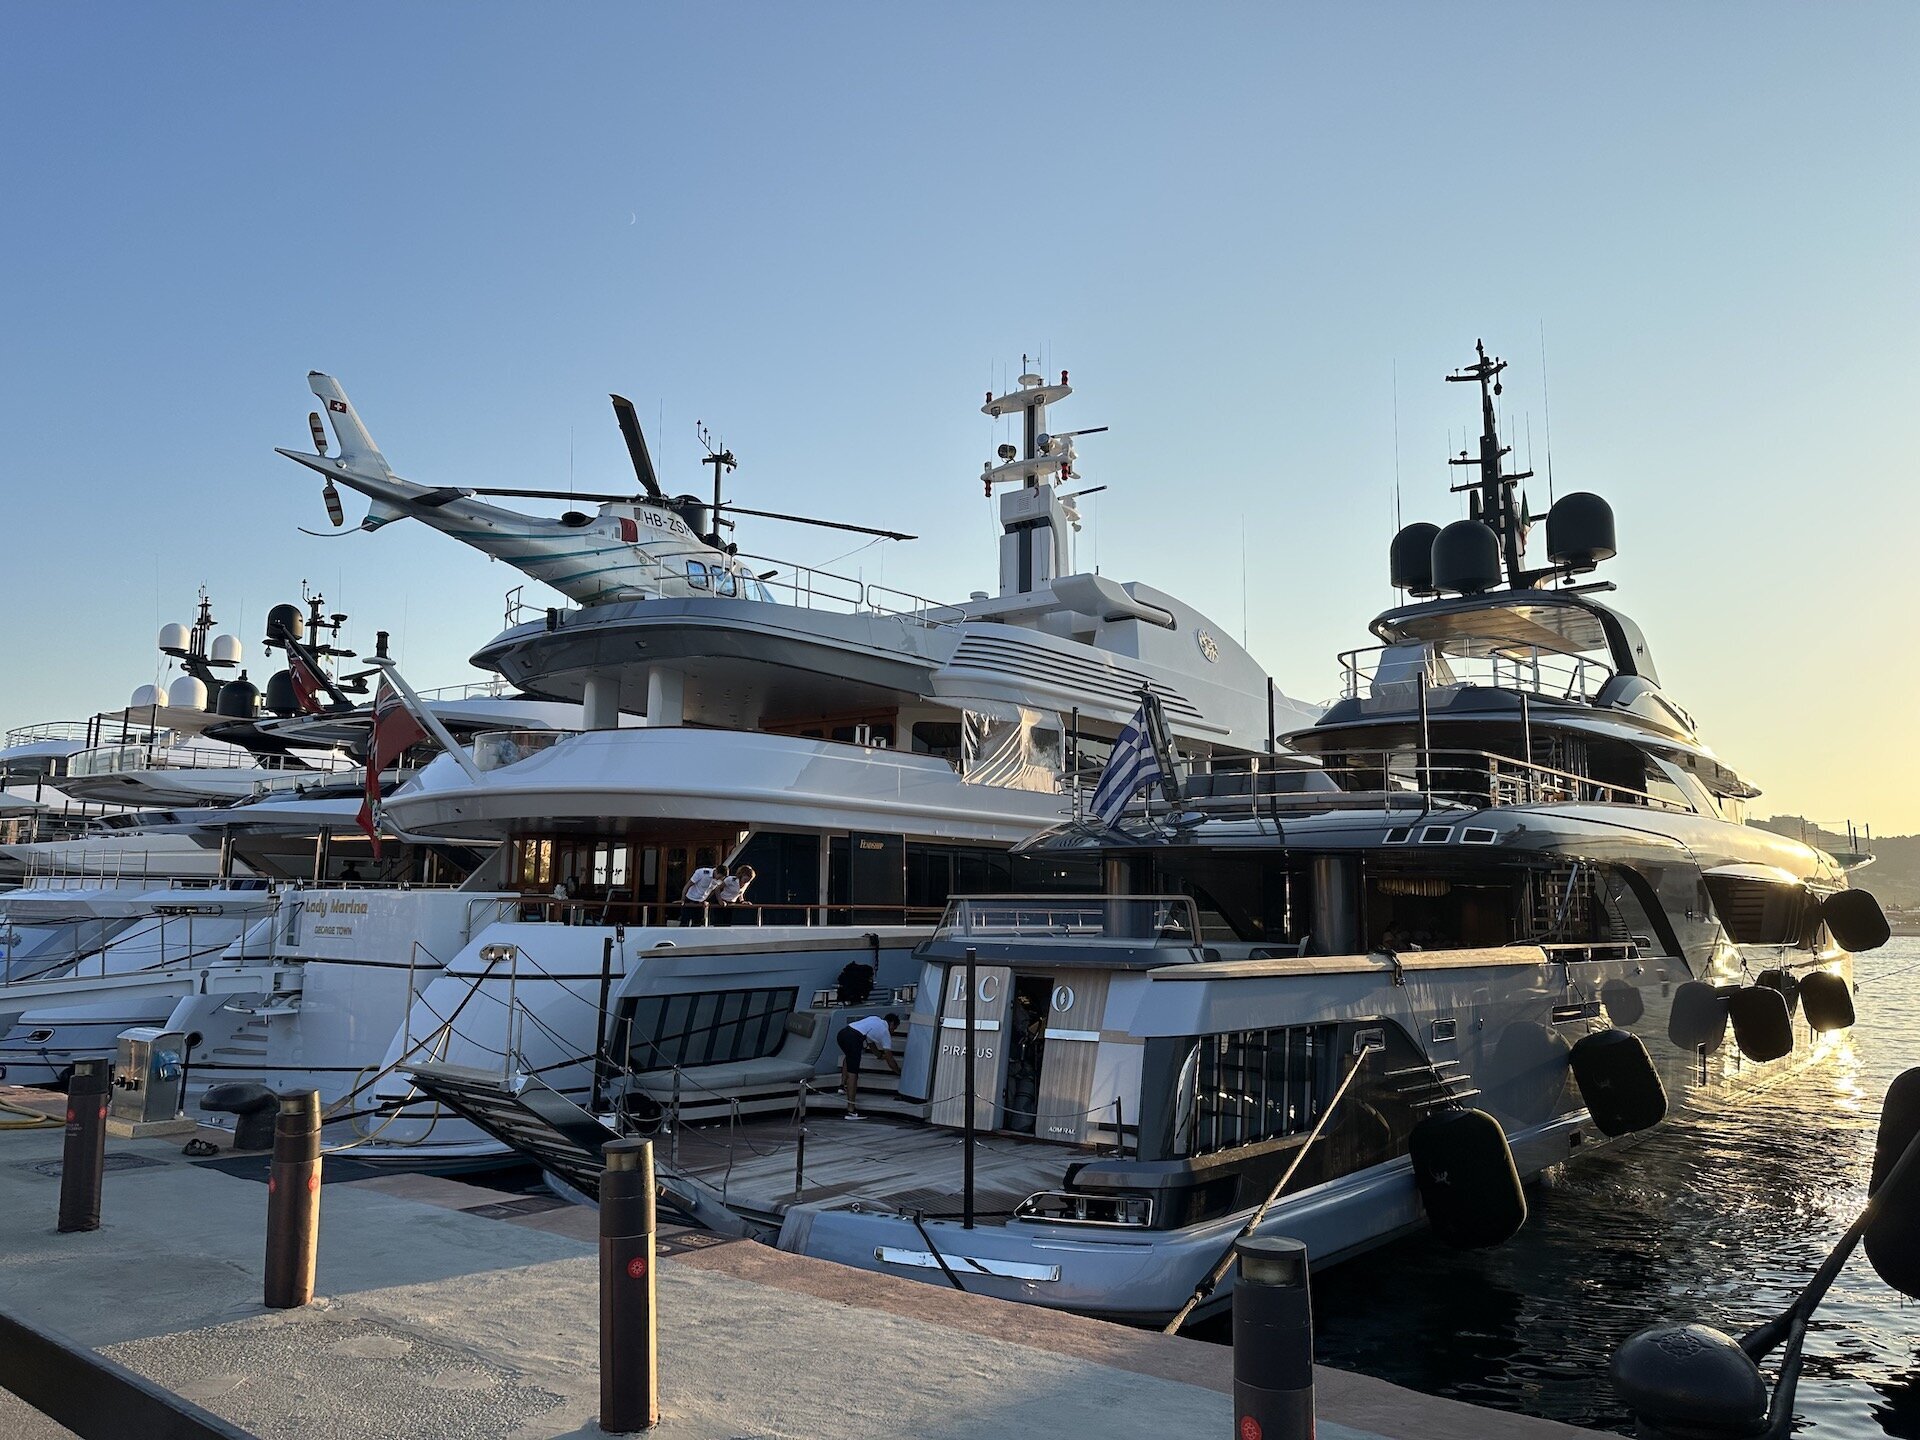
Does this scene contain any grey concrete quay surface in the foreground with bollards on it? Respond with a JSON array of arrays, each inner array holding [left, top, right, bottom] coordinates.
[[0, 1087, 1586, 1440]]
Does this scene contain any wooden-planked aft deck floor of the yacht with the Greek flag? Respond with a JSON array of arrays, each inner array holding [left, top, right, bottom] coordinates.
[[655, 1110, 1096, 1221]]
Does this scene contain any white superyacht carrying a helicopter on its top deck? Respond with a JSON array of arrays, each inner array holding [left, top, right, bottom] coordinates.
[[270, 372, 1315, 1164]]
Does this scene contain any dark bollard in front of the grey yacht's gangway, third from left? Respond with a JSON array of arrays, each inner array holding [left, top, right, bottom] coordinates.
[[601, 1140, 660, 1434]]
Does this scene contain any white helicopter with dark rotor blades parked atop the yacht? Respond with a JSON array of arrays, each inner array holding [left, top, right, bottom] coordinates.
[[276, 371, 914, 605]]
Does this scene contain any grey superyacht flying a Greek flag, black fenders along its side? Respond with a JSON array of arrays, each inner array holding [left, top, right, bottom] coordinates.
[[420, 349, 1887, 1325]]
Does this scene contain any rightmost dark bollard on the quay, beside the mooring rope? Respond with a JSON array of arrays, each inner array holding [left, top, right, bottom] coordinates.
[[1233, 1236, 1313, 1440]]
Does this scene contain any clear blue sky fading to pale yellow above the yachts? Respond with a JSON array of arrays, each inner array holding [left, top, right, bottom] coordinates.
[[0, 0, 1920, 833]]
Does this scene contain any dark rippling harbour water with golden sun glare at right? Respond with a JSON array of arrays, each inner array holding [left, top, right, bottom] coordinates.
[[1315, 939, 1920, 1440]]
